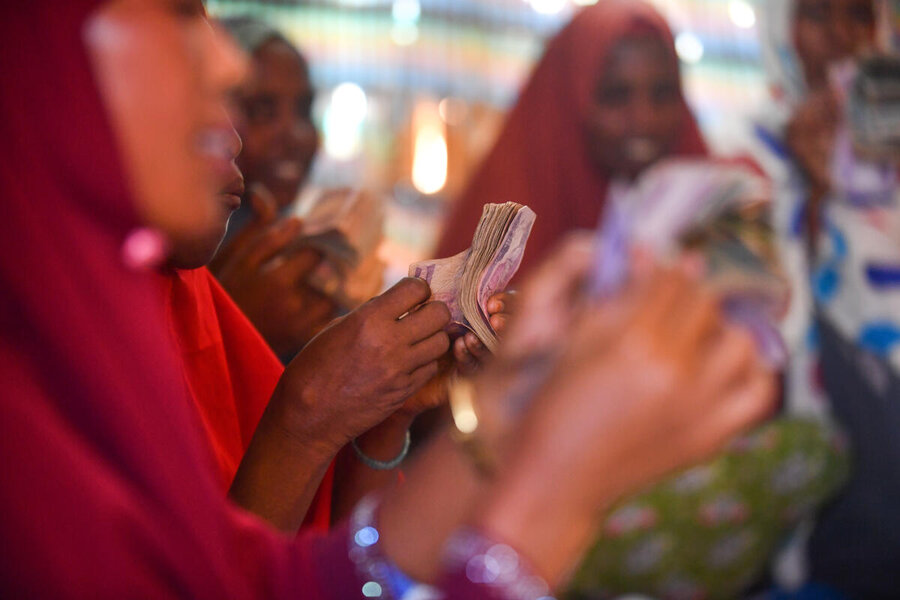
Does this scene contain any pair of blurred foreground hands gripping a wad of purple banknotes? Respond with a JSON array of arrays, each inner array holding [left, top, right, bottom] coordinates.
[[464, 242, 775, 582]]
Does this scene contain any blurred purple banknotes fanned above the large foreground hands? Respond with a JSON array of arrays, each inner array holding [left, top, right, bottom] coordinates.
[[591, 159, 790, 365]]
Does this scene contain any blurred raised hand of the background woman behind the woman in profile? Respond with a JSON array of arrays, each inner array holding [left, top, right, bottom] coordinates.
[[214, 192, 336, 356]]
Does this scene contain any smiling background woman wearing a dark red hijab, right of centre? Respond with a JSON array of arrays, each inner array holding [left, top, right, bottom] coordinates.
[[436, 0, 706, 273]]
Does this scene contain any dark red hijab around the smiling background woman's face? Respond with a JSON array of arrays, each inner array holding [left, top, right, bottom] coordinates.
[[436, 0, 707, 273]]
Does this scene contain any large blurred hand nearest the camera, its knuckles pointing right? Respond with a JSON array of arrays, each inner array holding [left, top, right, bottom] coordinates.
[[478, 258, 775, 582]]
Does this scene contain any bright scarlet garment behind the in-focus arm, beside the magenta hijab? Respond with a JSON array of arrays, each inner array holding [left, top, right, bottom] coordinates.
[[162, 268, 334, 531]]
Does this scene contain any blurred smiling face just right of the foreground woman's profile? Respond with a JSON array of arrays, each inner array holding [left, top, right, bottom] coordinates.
[[236, 40, 319, 208]]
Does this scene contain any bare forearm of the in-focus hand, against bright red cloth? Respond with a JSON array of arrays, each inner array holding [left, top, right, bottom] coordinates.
[[229, 402, 336, 532]]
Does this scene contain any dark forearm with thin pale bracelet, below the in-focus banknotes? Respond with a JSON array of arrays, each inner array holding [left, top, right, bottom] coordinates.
[[332, 414, 412, 522]]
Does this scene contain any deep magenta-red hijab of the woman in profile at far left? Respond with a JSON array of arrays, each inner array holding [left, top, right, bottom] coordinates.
[[0, 0, 340, 599]]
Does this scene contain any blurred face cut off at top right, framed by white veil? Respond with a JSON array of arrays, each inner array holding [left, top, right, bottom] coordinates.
[[793, 0, 875, 89]]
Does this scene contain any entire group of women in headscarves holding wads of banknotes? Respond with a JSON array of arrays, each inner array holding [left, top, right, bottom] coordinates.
[[0, 0, 900, 600]]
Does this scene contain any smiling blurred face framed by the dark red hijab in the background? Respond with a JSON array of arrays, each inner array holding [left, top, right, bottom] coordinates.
[[585, 38, 683, 179]]
